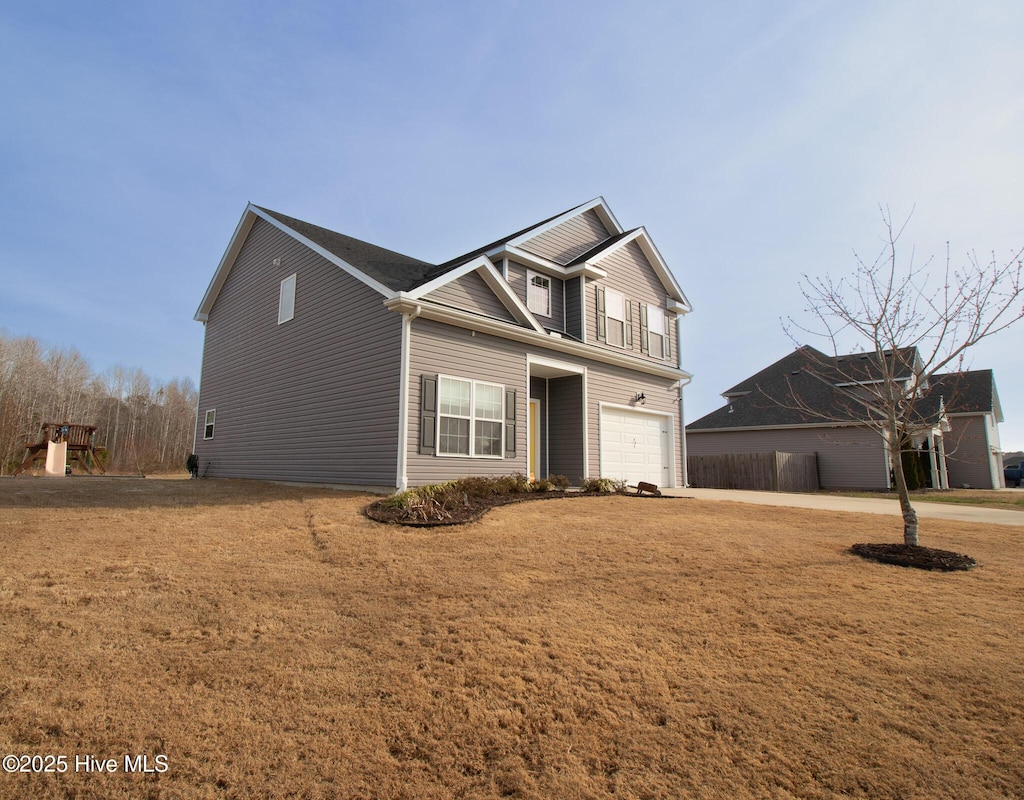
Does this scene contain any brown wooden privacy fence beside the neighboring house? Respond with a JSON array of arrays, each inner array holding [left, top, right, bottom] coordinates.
[[686, 452, 820, 492]]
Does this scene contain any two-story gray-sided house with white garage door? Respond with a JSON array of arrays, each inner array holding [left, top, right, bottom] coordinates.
[[196, 198, 690, 489]]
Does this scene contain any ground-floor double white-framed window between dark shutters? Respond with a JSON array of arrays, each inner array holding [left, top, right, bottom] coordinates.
[[437, 377, 505, 458]]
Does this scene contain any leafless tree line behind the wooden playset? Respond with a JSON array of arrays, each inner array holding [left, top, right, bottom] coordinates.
[[0, 331, 199, 475]]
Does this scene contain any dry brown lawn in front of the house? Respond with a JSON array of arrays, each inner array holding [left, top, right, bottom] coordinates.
[[0, 478, 1024, 800]]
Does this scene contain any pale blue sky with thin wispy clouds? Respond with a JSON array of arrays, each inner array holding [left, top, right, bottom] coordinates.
[[0, 0, 1024, 450]]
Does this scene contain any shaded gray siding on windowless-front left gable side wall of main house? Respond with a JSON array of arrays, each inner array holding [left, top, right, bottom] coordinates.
[[196, 215, 401, 486]]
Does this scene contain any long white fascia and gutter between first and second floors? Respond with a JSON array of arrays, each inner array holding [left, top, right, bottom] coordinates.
[[384, 293, 693, 380]]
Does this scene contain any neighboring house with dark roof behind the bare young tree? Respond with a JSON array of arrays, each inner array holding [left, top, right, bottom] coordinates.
[[686, 346, 1002, 490]]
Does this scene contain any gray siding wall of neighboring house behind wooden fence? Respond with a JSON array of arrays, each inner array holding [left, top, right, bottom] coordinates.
[[686, 427, 889, 489]]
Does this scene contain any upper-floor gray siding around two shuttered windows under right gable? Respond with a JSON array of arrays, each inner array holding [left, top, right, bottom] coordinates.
[[584, 242, 678, 364]]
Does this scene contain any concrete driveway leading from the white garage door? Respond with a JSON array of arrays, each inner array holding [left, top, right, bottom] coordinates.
[[662, 489, 1024, 527]]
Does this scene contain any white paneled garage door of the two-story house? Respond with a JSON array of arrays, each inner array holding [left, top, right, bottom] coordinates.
[[601, 409, 672, 487]]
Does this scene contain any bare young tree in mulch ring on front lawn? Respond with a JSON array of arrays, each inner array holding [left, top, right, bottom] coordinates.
[[783, 209, 1024, 546]]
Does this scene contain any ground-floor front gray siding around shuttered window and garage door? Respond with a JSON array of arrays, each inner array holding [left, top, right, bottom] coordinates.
[[407, 319, 682, 486]]
